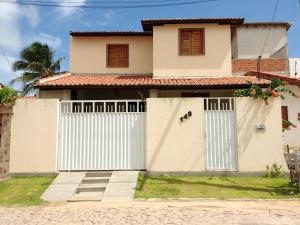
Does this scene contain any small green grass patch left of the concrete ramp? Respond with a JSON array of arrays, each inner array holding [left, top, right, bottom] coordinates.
[[0, 177, 54, 206]]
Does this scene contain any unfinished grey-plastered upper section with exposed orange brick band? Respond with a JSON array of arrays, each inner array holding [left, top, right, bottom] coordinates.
[[232, 22, 291, 75]]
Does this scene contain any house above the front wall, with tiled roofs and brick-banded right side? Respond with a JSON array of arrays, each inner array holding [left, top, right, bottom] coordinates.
[[37, 18, 290, 100]]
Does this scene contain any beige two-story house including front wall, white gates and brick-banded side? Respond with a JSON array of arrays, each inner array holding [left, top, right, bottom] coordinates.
[[6, 18, 290, 174]]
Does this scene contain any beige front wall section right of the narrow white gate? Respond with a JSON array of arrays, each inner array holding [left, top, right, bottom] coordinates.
[[236, 98, 287, 172]]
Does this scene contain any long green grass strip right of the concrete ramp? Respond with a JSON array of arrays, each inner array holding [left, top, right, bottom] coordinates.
[[135, 175, 300, 199]]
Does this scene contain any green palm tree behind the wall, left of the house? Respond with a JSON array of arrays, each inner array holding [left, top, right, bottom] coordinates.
[[10, 42, 64, 96]]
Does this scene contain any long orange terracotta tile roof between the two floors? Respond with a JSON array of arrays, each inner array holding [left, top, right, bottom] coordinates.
[[36, 73, 270, 88]]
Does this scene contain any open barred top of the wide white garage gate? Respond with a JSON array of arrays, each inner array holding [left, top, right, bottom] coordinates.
[[60, 100, 146, 113]]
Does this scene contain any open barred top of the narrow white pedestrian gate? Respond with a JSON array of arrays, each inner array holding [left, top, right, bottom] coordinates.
[[204, 98, 235, 111]]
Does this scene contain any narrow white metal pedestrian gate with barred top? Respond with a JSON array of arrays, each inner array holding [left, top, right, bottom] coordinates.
[[204, 98, 237, 171]]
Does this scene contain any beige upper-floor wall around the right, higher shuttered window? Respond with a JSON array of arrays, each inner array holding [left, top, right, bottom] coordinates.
[[153, 24, 231, 78]]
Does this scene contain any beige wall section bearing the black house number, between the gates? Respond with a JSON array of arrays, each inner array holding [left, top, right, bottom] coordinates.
[[145, 98, 204, 172]]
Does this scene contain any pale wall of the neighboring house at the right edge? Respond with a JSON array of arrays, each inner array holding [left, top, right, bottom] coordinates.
[[281, 85, 300, 148]]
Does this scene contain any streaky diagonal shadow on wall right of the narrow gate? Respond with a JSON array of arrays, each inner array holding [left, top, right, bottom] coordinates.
[[237, 99, 274, 156]]
